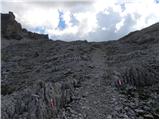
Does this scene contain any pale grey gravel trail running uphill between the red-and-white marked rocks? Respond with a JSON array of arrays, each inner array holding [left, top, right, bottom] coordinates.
[[59, 49, 113, 118]]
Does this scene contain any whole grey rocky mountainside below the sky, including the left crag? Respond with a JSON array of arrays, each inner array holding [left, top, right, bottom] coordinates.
[[1, 12, 159, 119]]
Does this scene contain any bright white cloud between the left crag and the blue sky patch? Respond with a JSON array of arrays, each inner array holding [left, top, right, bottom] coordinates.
[[17, 8, 59, 29]]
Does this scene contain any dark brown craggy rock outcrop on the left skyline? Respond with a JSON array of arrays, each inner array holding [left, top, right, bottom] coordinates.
[[1, 12, 48, 40]]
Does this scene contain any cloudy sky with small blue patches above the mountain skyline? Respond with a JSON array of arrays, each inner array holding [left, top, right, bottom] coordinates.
[[0, 0, 160, 41]]
